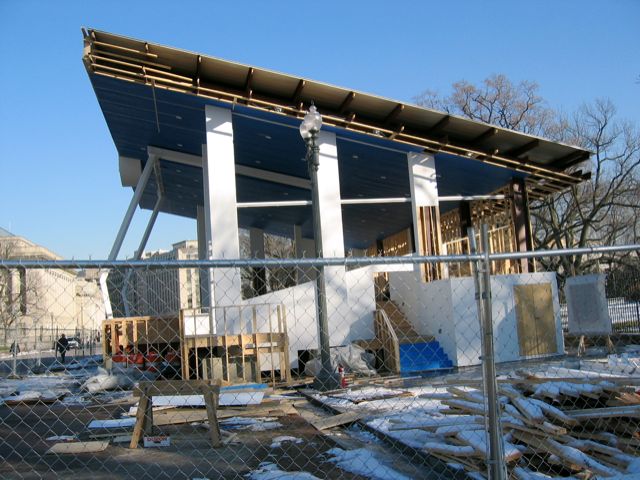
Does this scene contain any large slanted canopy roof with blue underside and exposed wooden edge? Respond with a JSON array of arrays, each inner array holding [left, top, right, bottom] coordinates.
[[83, 30, 589, 247]]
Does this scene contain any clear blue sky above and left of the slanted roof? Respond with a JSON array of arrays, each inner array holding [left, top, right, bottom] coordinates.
[[0, 0, 640, 259]]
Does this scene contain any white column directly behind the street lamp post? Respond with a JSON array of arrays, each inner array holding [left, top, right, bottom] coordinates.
[[318, 131, 353, 345]]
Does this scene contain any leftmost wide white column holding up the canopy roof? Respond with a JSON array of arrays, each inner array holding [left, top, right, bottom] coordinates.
[[202, 105, 242, 316]]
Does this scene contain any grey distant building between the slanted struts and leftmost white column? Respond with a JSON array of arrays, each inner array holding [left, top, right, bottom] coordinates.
[[107, 240, 200, 317]]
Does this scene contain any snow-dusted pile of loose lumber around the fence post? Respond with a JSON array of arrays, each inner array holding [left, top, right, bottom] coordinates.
[[407, 375, 640, 478]]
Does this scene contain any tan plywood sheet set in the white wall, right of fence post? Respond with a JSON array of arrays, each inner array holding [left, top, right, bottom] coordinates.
[[513, 283, 558, 357]]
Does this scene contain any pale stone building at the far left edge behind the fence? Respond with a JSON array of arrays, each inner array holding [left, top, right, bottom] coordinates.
[[0, 228, 105, 343]]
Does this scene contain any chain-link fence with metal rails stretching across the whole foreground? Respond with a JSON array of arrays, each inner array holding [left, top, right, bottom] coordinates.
[[0, 242, 640, 479]]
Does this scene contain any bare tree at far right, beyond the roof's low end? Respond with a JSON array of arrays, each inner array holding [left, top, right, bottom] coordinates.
[[531, 100, 640, 275]]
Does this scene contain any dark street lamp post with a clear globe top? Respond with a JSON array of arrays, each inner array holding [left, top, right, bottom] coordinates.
[[300, 103, 340, 391]]
